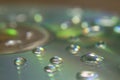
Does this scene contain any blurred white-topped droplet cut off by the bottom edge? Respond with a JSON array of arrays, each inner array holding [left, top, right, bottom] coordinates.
[[76, 71, 98, 80]]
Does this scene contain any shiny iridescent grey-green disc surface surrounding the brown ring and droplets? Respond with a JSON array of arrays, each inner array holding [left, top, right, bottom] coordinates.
[[0, 7, 120, 80]]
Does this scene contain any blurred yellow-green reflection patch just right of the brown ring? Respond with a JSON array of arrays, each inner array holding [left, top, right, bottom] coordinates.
[[49, 25, 82, 39]]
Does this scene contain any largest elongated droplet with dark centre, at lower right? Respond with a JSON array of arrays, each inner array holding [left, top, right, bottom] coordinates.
[[81, 53, 104, 64]]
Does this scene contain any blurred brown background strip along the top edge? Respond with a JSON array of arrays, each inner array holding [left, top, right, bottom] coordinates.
[[0, 0, 120, 14]]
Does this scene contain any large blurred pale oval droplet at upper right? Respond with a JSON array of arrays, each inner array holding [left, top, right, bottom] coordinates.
[[95, 16, 119, 27]]
